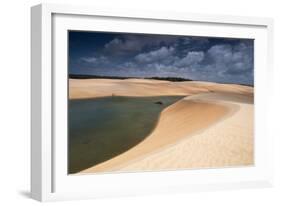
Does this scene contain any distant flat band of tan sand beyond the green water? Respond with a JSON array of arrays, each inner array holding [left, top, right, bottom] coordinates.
[[69, 79, 253, 99]]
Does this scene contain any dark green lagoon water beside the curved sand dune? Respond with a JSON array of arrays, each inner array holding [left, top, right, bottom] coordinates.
[[68, 96, 182, 174]]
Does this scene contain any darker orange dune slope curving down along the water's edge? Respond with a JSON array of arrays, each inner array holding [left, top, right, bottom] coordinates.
[[78, 93, 239, 174]]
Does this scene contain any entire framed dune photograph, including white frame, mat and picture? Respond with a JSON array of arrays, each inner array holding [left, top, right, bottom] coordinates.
[[31, 4, 273, 201]]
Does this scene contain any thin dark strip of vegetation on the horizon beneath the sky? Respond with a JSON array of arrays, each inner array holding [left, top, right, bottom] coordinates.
[[69, 74, 192, 82]]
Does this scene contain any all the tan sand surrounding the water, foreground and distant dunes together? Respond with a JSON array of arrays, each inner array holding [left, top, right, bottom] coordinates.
[[69, 79, 254, 174]]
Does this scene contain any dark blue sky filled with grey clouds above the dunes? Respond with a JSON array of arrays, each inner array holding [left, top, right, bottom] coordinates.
[[69, 31, 254, 85]]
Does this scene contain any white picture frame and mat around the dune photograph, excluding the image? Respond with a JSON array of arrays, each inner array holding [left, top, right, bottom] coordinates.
[[31, 4, 273, 201]]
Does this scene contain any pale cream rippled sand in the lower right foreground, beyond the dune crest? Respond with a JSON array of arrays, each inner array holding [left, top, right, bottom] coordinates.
[[118, 94, 254, 171]]
